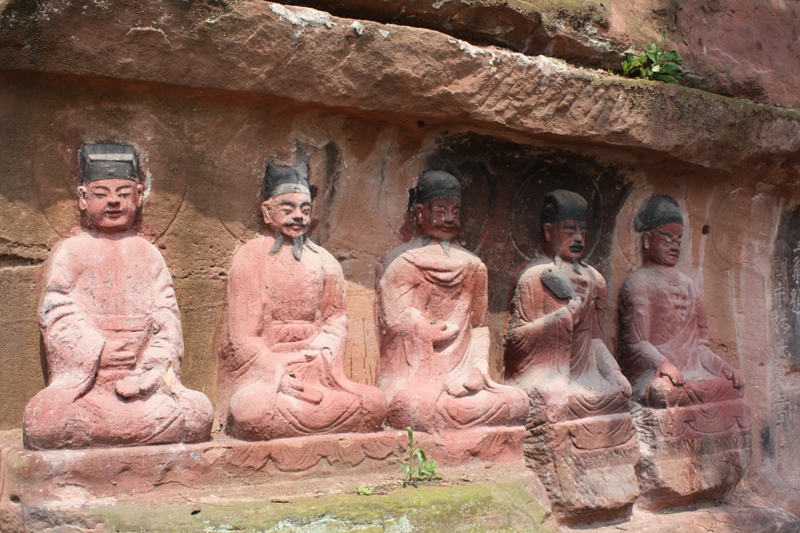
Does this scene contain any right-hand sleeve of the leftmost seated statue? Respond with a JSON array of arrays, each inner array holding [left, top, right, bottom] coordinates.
[[141, 243, 183, 377]]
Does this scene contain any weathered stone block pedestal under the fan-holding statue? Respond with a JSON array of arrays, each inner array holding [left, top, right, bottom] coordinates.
[[525, 413, 639, 525]]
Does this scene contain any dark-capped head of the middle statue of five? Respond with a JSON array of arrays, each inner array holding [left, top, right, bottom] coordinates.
[[408, 170, 461, 241]]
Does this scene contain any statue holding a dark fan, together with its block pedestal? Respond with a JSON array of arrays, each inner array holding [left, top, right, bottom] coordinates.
[[505, 189, 638, 519]]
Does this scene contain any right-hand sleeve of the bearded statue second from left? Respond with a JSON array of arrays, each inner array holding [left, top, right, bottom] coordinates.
[[305, 249, 347, 362]]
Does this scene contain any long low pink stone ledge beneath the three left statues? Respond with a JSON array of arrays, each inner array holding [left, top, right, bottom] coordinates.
[[0, 427, 525, 506]]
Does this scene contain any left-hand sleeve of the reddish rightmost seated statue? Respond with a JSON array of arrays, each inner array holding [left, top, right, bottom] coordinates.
[[619, 273, 666, 378]]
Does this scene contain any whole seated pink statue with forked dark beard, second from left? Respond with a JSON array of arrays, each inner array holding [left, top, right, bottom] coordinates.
[[217, 162, 386, 440]]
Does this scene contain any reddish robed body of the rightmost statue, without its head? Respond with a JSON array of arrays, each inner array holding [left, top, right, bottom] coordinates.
[[619, 265, 744, 407]]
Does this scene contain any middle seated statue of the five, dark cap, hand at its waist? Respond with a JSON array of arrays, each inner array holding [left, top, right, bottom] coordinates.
[[378, 171, 528, 432]]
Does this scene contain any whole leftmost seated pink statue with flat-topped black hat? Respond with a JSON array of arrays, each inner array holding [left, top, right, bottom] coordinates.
[[23, 145, 213, 449]]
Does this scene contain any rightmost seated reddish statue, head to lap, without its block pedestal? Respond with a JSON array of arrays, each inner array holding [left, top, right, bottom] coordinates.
[[619, 196, 744, 425]]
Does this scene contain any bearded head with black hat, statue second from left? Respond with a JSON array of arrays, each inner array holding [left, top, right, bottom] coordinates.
[[261, 161, 315, 239]]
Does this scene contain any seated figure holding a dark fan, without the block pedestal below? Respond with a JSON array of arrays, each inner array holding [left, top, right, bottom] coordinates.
[[505, 189, 632, 436]]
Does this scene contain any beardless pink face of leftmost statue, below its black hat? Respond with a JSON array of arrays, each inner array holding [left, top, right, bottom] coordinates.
[[78, 178, 143, 233]]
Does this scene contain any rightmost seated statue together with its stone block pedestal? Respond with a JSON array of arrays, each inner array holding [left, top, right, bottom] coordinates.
[[618, 196, 751, 508]]
